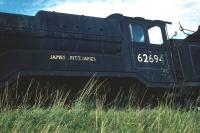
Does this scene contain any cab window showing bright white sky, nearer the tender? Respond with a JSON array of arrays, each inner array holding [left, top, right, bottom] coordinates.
[[148, 26, 163, 45]]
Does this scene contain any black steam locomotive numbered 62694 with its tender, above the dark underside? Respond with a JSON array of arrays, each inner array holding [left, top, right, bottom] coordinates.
[[0, 11, 200, 88]]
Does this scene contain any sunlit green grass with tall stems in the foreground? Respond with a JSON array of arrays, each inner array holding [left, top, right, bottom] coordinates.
[[0, 78, 200, 133]]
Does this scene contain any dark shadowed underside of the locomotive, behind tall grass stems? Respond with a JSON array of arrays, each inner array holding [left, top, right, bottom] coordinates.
[[0, 77, 200, 110]]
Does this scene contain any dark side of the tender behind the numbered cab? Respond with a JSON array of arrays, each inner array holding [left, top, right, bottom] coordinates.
[[171, 40, 200, 87]]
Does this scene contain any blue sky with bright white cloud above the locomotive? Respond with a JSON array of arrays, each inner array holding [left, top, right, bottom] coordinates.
[[0, 0, 200, 39]]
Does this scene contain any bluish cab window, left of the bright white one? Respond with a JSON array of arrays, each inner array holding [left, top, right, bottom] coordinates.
[[129, 23, 145, 43]]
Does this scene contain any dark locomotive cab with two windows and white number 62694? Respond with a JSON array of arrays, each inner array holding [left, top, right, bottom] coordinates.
[[122, 18, 174, 87]]
